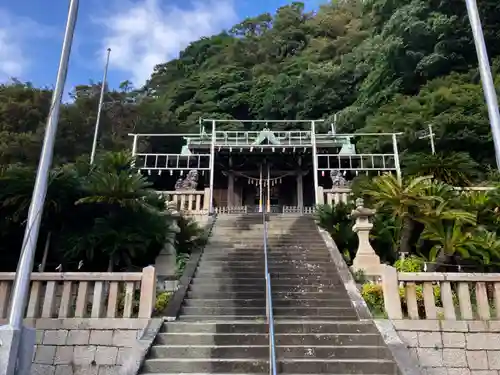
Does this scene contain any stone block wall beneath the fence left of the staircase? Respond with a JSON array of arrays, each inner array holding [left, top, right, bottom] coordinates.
[[4, 318, 149, 375]]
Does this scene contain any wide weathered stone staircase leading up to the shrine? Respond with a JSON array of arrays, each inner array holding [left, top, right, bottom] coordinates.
[[142, 215, 398, 375]]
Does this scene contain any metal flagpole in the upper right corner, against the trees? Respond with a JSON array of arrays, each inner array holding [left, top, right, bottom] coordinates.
[[465, 0, 500, 169]]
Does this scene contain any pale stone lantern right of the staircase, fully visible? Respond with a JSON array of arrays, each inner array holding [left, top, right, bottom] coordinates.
[[351, 198, 380, 275]]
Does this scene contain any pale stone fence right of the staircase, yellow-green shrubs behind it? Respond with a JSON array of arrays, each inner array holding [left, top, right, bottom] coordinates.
[[381, 266, 500, 320]]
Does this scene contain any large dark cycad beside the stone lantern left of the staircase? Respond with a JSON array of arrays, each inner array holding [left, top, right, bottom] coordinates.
[[71, 153, 171, 271]]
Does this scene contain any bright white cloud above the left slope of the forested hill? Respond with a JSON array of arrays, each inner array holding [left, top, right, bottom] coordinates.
[[99, 0, 237, 86]]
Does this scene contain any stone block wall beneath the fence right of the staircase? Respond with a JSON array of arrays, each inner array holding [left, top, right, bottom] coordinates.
[[392, 320, 500, 375]]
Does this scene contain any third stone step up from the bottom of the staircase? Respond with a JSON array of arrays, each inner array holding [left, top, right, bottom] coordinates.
[[154, 334, 384, 347]]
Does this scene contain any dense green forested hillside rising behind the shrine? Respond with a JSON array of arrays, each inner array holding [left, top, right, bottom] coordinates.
[[0, 0, 500, 167]]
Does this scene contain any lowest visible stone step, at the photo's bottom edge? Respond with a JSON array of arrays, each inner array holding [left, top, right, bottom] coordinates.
[[143, 358, 398, 375]]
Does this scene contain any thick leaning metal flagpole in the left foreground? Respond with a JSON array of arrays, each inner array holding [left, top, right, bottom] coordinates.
[[9, 0, 79, 329]]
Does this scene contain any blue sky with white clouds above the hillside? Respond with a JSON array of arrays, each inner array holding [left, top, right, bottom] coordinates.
[[0, 0, 322, 92]]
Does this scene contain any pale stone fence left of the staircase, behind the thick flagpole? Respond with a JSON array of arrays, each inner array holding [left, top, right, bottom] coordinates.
[[0, 266, 156, 319]]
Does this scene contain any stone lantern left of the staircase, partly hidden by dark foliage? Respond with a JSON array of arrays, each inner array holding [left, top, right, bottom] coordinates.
[[155, 206, 180, 291]]
